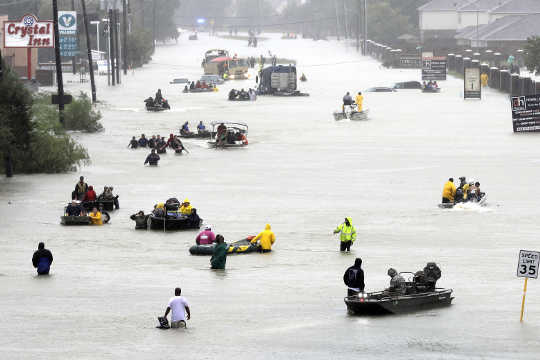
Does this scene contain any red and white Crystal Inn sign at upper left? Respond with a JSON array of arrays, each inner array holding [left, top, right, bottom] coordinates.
[[4, 14, 54, 48]]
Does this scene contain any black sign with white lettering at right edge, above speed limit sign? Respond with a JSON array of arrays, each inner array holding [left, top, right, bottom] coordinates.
[[510, 94, 540, 132]]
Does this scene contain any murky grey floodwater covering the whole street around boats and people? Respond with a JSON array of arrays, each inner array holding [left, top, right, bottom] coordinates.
[[0, 34, 540, 359]]
